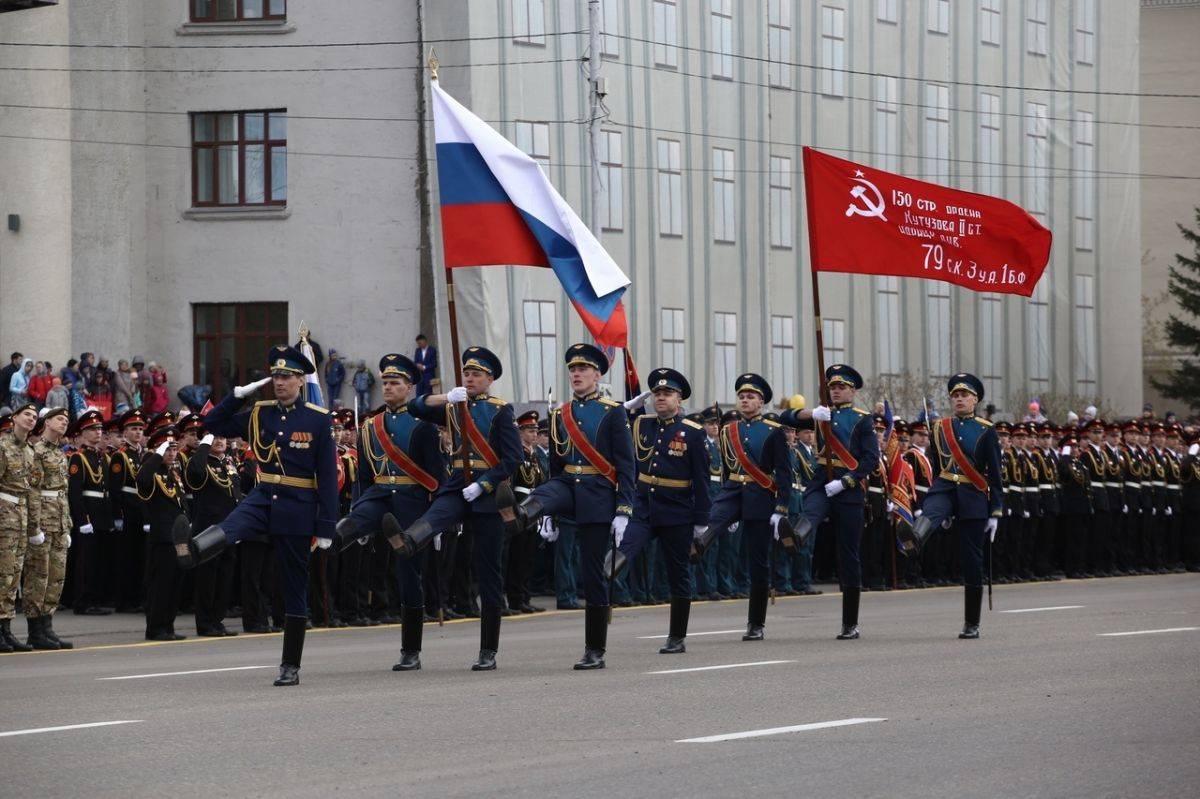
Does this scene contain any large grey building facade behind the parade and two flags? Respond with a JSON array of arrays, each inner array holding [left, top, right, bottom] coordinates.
[[0, 0, 1142, 414]]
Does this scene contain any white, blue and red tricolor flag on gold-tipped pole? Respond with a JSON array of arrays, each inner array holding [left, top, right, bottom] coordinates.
[[431, 80, 629, 347]]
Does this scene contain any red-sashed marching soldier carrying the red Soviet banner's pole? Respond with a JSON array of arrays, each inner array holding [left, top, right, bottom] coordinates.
[[785, 364, 880, 641]]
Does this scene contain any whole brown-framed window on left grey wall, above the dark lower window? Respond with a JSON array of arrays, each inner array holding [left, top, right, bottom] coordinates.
[[191, 110, 288, 206]]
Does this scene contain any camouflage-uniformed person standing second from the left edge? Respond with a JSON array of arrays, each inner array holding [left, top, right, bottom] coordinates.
[[20, 408, 73, 649]]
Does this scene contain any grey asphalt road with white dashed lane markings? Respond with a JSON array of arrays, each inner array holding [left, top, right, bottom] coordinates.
[[0, 575, 1200, 799]]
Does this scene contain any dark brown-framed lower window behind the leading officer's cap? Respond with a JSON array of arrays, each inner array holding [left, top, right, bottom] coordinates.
[[192, 302, 288, 397]]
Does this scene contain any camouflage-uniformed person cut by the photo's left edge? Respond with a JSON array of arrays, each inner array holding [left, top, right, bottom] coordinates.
[[0, 402, 44, 653]]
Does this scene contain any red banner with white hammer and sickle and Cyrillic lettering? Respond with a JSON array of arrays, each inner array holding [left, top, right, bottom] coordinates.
[[804, 148, 1050, 296]]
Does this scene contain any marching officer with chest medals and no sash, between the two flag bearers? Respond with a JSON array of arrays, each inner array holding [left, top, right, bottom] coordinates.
[[605, 368, 709, 655]]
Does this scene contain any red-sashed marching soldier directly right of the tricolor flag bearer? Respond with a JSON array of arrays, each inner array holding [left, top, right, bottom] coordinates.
[[518, 344, 646, 669]]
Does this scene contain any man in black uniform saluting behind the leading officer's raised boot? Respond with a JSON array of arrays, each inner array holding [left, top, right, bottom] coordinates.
[[180, 427, 241, 638]]
